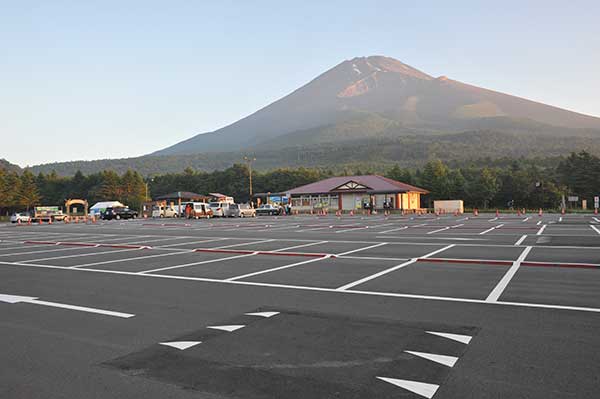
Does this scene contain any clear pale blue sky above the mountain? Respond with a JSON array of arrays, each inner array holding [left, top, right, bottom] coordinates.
[[0, 0, 600, 166]]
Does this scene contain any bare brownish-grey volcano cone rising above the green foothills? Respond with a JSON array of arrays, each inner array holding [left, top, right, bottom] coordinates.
[[152, 56, 600, 155]]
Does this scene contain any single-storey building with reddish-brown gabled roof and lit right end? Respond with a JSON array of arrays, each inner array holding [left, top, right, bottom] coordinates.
[[285, 175, 429, 211]]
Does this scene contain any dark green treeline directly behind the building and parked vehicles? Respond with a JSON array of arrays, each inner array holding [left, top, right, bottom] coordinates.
[[0, 151, 600, 214]]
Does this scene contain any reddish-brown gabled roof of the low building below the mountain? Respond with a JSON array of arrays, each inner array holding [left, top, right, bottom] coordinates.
[[288, 175, 429, 195]]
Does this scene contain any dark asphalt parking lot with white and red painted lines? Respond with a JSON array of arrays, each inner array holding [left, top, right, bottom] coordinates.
[[0, 214, 600, 398]]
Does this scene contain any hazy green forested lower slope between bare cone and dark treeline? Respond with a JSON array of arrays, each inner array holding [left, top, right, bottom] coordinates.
[[29, 131, 600, 176]]
